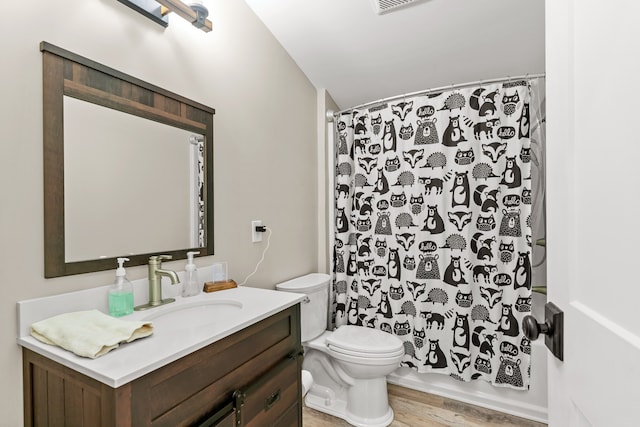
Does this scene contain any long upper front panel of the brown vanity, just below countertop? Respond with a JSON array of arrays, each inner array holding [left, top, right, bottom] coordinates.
[[132, 307, 300, 427]]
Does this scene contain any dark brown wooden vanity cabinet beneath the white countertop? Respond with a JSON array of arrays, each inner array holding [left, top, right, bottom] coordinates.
[[23, 304, 302, 427]]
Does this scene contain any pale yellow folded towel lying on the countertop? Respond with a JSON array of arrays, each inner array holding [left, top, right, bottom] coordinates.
[[31, 310, 153, 359]]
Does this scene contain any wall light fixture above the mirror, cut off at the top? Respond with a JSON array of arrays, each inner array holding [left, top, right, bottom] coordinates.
[[118, 0, 212, 33]]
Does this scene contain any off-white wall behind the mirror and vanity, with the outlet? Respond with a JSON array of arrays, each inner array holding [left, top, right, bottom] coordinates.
[[0, 0, 318, 426]]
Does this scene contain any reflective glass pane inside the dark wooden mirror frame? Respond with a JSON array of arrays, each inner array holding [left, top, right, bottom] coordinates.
[[64, 96, 204, 262]]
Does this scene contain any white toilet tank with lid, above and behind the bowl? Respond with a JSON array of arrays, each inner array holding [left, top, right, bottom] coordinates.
[[276, 273, 330, 342]]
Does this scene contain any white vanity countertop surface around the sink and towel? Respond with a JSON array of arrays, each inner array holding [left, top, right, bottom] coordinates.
[[18, 278, 305, 388]]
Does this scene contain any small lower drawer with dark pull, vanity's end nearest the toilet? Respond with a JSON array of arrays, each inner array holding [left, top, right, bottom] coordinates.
[[234, 358, 300, 427]]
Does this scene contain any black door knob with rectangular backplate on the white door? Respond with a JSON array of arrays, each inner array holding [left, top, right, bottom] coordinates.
[[522, 302, 564, 360]]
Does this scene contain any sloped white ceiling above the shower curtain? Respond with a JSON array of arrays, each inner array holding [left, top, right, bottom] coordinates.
[[245, 0, 544, 109]]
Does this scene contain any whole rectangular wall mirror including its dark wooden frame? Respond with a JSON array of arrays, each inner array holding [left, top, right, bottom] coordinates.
[[41, 42, 215, 277]]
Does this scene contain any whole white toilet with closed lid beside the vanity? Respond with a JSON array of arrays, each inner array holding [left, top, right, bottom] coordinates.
[[276, 273, 404, 427]]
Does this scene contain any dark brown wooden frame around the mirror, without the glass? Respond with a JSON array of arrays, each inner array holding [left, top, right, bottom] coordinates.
[[40, 42, 215, 278]]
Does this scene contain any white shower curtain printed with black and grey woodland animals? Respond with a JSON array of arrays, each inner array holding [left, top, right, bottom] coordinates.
[[333, 81, 532, 389]]
